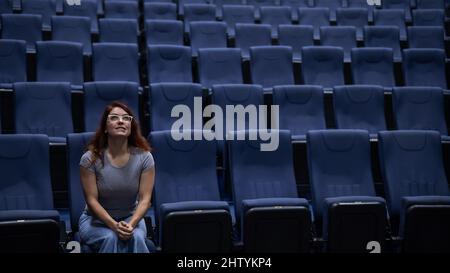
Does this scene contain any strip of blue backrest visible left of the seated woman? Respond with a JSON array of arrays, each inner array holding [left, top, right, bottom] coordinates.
[[67, 132, 94, 232]]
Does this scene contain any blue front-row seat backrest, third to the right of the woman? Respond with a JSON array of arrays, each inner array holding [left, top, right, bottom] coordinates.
[[306, 130, 375, 219]]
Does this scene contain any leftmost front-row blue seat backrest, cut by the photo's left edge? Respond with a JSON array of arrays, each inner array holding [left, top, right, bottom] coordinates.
[[0, 134, 53, 211]]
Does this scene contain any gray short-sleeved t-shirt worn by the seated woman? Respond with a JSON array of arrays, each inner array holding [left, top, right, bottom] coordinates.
[[80, 148, 155, 219]]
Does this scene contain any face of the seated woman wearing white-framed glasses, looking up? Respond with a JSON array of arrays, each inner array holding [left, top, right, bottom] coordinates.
[[106, 107, 133, 137]]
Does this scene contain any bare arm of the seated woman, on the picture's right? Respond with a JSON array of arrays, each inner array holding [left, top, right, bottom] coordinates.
[[129, 167, 155, 229]]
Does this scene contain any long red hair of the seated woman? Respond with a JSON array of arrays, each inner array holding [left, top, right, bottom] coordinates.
[[87, 101, 151, 164]]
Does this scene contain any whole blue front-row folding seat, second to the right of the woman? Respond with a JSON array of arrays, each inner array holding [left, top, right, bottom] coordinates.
[[228, 130, 311, 253]]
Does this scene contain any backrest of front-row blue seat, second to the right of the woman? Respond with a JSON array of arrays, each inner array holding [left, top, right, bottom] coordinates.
[[228, 130, 298, 222]]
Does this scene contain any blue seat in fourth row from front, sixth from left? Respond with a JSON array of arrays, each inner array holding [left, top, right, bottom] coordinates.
[[236, 23, 272, 59]]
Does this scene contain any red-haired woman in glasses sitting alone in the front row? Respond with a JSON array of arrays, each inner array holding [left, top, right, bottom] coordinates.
[[79, 102, 155, 253]]
